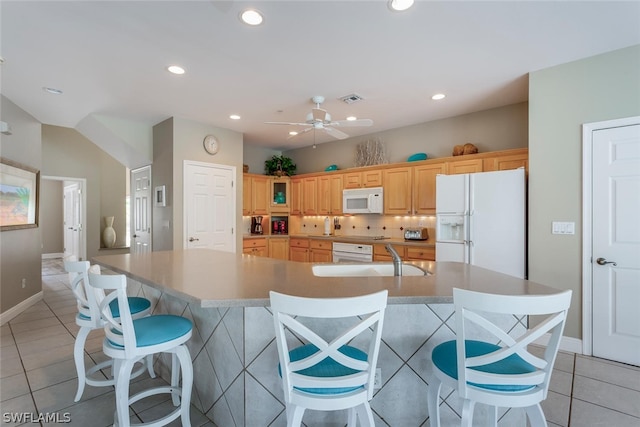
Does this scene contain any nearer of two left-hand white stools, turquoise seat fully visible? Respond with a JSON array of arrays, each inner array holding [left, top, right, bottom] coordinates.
[[89, 272, 193, 427]]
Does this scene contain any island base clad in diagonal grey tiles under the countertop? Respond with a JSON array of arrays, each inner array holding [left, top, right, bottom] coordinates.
[[129, 279, 525, 427]]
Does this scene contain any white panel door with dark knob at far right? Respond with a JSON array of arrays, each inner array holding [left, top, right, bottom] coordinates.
[[592, 125, 640, 365]]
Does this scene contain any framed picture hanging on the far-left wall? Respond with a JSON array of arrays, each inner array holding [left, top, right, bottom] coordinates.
[[0, 157, 40, 231]]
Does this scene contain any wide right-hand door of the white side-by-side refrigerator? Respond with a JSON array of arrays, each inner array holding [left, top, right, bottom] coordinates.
[[469, 169, 526, 279]]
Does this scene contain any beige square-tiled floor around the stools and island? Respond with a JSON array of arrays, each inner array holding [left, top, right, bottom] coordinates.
[[0, 260, 640, 427]]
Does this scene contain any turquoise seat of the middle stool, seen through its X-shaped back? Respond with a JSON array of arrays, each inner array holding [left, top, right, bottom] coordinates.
[[278, 344, 367, 394]]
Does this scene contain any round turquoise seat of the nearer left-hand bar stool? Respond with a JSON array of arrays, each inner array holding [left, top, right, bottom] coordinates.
[[109, 314, 193, 347]]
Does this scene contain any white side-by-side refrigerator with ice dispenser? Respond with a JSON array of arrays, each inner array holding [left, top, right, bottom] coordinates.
[[436, 168, 526, 278]]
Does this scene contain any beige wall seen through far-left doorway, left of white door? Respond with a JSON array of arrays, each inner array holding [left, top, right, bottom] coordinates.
[[40, 179, 64, 254]]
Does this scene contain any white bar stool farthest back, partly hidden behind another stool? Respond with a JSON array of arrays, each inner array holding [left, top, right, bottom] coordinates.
[[64, 257, 156, 402]]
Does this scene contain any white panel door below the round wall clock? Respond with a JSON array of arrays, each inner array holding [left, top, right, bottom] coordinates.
[[184, 162, 236, 252]]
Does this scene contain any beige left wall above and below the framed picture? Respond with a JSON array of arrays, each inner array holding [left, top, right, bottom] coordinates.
[[0, 95, 42, 313]]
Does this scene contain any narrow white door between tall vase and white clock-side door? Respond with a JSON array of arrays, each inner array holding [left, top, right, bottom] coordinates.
[[130, 166, 152, 253]]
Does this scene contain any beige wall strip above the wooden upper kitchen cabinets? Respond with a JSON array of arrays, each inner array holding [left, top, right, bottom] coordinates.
[[288, 102, 528, 174]]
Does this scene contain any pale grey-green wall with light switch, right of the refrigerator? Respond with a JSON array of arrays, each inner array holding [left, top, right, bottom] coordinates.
[[529, 45, 640, 338]]
